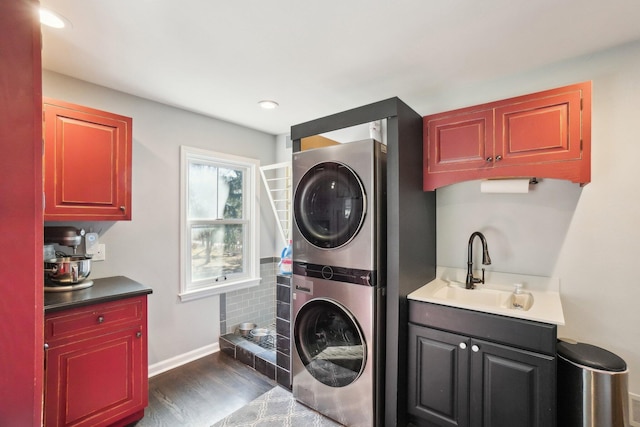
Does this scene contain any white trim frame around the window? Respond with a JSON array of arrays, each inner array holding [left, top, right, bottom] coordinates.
[[178, 145, 260, 302]]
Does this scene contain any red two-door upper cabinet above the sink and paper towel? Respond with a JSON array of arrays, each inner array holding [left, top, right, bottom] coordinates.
[[423, 82, 591, 190]]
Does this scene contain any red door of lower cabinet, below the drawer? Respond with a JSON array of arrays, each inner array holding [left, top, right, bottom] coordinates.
[[45, 328, 147, 427]]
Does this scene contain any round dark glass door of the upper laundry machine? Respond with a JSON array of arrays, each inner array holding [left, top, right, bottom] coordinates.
[[293, 162, 366, 249]]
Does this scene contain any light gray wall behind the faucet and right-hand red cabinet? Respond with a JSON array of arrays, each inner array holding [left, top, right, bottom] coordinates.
[[420, 43, 640, 394]]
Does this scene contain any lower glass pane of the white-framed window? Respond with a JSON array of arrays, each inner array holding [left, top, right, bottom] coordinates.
[[191, 224, 244, 282]]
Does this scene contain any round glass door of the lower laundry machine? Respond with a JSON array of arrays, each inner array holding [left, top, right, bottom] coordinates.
[[294, 298, 367, 387]]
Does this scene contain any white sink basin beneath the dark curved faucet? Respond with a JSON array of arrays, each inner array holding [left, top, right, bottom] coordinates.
[[433, 282, 533, 311]]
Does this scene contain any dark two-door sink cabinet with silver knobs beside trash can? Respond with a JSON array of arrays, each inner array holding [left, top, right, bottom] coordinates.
[[408, 301, 557, 427]]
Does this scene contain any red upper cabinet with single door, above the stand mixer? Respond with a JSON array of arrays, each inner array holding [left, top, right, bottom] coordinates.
[[43, 98, 132, 221]]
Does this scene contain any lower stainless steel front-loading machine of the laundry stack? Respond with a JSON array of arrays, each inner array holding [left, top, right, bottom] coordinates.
[[292, 271, 385, 427]]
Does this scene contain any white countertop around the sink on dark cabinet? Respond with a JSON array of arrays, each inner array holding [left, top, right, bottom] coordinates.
[[408, 267, 564, 325]]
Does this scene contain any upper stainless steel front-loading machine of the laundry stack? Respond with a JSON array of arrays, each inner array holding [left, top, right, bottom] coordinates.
[[292, 139, 386, 276]]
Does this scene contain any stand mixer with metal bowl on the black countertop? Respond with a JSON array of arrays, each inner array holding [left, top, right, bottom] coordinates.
[[44, 227, 93, 292]]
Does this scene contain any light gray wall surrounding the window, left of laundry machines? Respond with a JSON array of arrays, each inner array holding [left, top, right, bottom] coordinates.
[[43, 70, 279, 365]]
